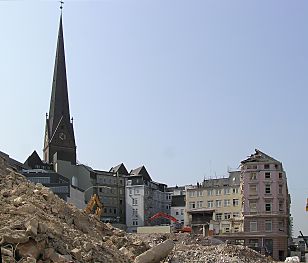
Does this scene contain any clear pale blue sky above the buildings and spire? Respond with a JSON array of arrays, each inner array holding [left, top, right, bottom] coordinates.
[[0, 0, 308, 236]]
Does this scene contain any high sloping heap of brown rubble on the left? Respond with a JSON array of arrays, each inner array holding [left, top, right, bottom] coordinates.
[[0, 158, 149, 263]]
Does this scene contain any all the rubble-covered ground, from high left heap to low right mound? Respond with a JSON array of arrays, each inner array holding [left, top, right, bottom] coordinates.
[[0, 157, 282, 263]]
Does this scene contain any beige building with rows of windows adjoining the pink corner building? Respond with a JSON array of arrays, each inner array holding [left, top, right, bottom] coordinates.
[[184, 171, 243, 235]]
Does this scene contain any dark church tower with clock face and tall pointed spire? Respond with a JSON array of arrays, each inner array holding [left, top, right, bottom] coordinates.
[[43, 12, 76, 164]]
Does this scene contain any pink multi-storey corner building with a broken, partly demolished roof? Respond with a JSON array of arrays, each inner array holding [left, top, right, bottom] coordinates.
[[241, 150, 290, 260]]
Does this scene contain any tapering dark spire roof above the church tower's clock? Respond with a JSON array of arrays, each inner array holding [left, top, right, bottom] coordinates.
[[49, 13, 70, 134]]
